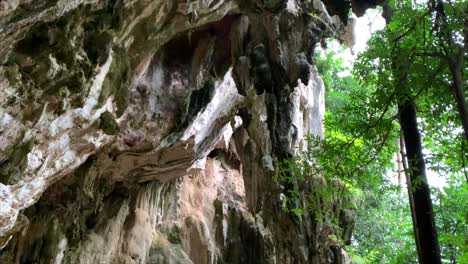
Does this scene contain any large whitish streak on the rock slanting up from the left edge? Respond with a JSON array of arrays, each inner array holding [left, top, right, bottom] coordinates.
[[0, 52, 112, 236]]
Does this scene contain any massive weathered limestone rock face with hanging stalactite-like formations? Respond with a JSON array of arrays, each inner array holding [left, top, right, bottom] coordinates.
[[0, 0, 377, 264]]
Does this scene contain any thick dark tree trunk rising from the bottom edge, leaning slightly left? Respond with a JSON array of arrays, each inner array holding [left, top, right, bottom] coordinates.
[[398, 100, 441, 264]]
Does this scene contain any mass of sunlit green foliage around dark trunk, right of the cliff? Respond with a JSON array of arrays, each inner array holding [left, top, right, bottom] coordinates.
[[277, 17, 468, 263]]
